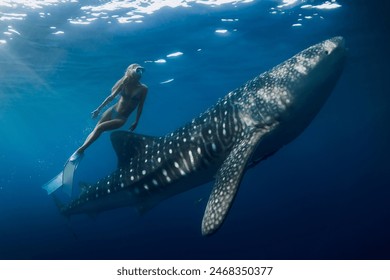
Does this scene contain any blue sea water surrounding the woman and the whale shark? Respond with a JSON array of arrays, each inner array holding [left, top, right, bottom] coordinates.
[[0, 0, 390, 259]]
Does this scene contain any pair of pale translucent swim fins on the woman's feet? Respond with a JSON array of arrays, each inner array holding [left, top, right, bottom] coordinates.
[[42, 155, 82, 196]]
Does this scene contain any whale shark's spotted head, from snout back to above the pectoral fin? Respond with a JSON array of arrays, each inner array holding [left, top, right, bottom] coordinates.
[[243, 37, 346, 137]]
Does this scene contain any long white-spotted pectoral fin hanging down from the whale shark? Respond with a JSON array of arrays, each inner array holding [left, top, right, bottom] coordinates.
[[202, 132, 263, 235]]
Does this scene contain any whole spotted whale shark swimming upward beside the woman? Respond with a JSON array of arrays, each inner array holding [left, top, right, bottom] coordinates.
[[53, 37, 346, 236]]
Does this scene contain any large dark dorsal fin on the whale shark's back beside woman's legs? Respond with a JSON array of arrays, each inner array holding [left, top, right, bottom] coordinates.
[[111, 130, 158, 167]]
